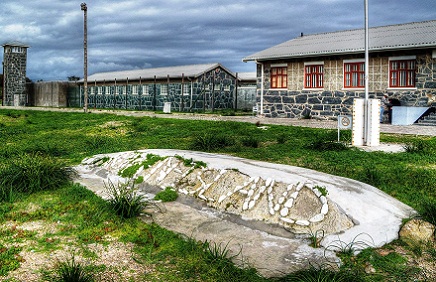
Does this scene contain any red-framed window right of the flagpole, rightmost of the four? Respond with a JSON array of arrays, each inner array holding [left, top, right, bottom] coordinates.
[[389, 60, 416, 88]]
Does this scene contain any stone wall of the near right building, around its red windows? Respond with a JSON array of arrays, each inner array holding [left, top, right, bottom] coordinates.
[[257, 50, 436, 119]]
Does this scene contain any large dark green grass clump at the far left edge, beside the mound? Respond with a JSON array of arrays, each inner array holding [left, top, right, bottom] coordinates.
[[0, 153, 75, 193]]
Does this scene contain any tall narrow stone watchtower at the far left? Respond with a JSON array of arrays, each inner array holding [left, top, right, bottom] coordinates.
[[3, 42, 29, 106]]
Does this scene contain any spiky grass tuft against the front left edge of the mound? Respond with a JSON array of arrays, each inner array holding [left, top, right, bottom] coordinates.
[[104, 180, 146, 218]]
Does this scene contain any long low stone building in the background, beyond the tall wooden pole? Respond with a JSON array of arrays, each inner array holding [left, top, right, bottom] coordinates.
[[68, 63, 256, 112]]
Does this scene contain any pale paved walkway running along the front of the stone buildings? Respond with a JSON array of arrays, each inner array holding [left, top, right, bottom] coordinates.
[[0, 106, 436, 136]]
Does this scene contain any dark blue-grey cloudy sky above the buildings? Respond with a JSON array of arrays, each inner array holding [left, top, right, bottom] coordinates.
[[0, 0, 436, 81]]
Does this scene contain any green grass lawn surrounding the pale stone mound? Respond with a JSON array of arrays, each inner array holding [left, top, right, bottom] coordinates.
[[0, 109, 436, 281]]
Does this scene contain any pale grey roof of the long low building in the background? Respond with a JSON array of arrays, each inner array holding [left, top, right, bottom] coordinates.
[[85, 63, 233, 82]]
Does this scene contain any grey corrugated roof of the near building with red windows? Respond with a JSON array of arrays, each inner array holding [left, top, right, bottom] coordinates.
[[243, 20, 436, 62]]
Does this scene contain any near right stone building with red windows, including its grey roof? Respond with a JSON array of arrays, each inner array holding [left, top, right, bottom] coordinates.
[[243, 20, 436, 119]]
